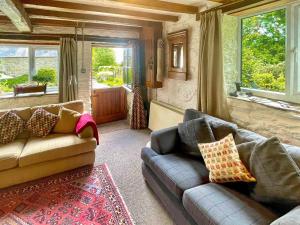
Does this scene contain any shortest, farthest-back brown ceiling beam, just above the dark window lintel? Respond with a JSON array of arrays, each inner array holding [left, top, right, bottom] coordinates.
[[31, 18, 141, 32]]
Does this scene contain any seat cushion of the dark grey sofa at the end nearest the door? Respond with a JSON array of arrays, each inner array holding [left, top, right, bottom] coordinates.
[[142, 148, 209, 200]]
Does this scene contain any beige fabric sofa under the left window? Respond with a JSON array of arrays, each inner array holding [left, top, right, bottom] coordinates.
[[0, 101, 97, 188]]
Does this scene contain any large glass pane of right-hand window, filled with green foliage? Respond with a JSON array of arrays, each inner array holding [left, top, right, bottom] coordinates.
[[242, 9, 287, 92]]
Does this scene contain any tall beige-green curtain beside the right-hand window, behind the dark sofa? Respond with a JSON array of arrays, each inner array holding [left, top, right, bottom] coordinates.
[[198, 10, 230, 120]]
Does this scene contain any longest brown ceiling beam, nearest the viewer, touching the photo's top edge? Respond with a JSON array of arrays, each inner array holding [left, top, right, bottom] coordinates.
[[22, 0, 178, 22]]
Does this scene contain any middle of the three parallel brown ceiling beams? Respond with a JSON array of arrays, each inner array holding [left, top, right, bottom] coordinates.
[[26, 9, 162, 27]]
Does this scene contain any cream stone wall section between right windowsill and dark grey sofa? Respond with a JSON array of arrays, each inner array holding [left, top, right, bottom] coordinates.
[[228, 98, 300, 146]]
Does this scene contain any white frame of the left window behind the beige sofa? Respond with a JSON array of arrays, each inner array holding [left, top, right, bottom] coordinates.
[[0, 44, 60, 96]]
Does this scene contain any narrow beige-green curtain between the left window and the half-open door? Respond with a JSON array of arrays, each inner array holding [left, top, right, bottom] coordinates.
[[59, 38, 78, 102]]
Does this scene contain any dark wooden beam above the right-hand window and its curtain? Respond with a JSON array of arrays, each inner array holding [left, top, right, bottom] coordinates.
[[197, 0, 278, 20]]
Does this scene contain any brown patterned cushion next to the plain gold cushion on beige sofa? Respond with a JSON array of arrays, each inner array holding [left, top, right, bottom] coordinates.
[[27, 108, 59, 137]]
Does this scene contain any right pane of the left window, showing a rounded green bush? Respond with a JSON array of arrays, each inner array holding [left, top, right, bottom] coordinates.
[[34, 48, 58, 92]]
